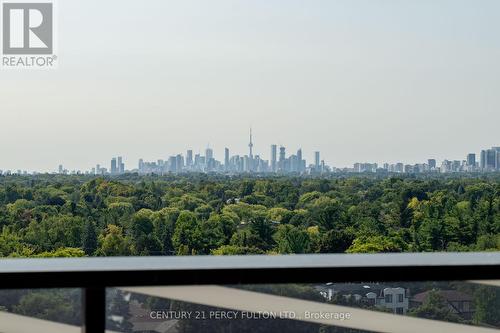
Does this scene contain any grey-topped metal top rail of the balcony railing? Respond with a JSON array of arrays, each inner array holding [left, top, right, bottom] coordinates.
[[0, 252, 500, 289]]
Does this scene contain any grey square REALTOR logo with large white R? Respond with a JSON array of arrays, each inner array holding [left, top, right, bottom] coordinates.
[[1, 0, 57, 68]]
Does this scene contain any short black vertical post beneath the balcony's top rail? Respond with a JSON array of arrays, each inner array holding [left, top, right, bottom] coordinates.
[[82, 287, 106, 333]]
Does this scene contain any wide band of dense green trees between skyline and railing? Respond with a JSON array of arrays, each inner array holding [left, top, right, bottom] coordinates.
[[0, 175, 500, 257]]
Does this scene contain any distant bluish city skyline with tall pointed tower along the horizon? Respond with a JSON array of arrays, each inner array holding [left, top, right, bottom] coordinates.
[[0, 128, 500, 175]]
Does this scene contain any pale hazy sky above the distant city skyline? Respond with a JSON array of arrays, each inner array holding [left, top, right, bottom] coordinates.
[[0, 0, 500, 171]]
